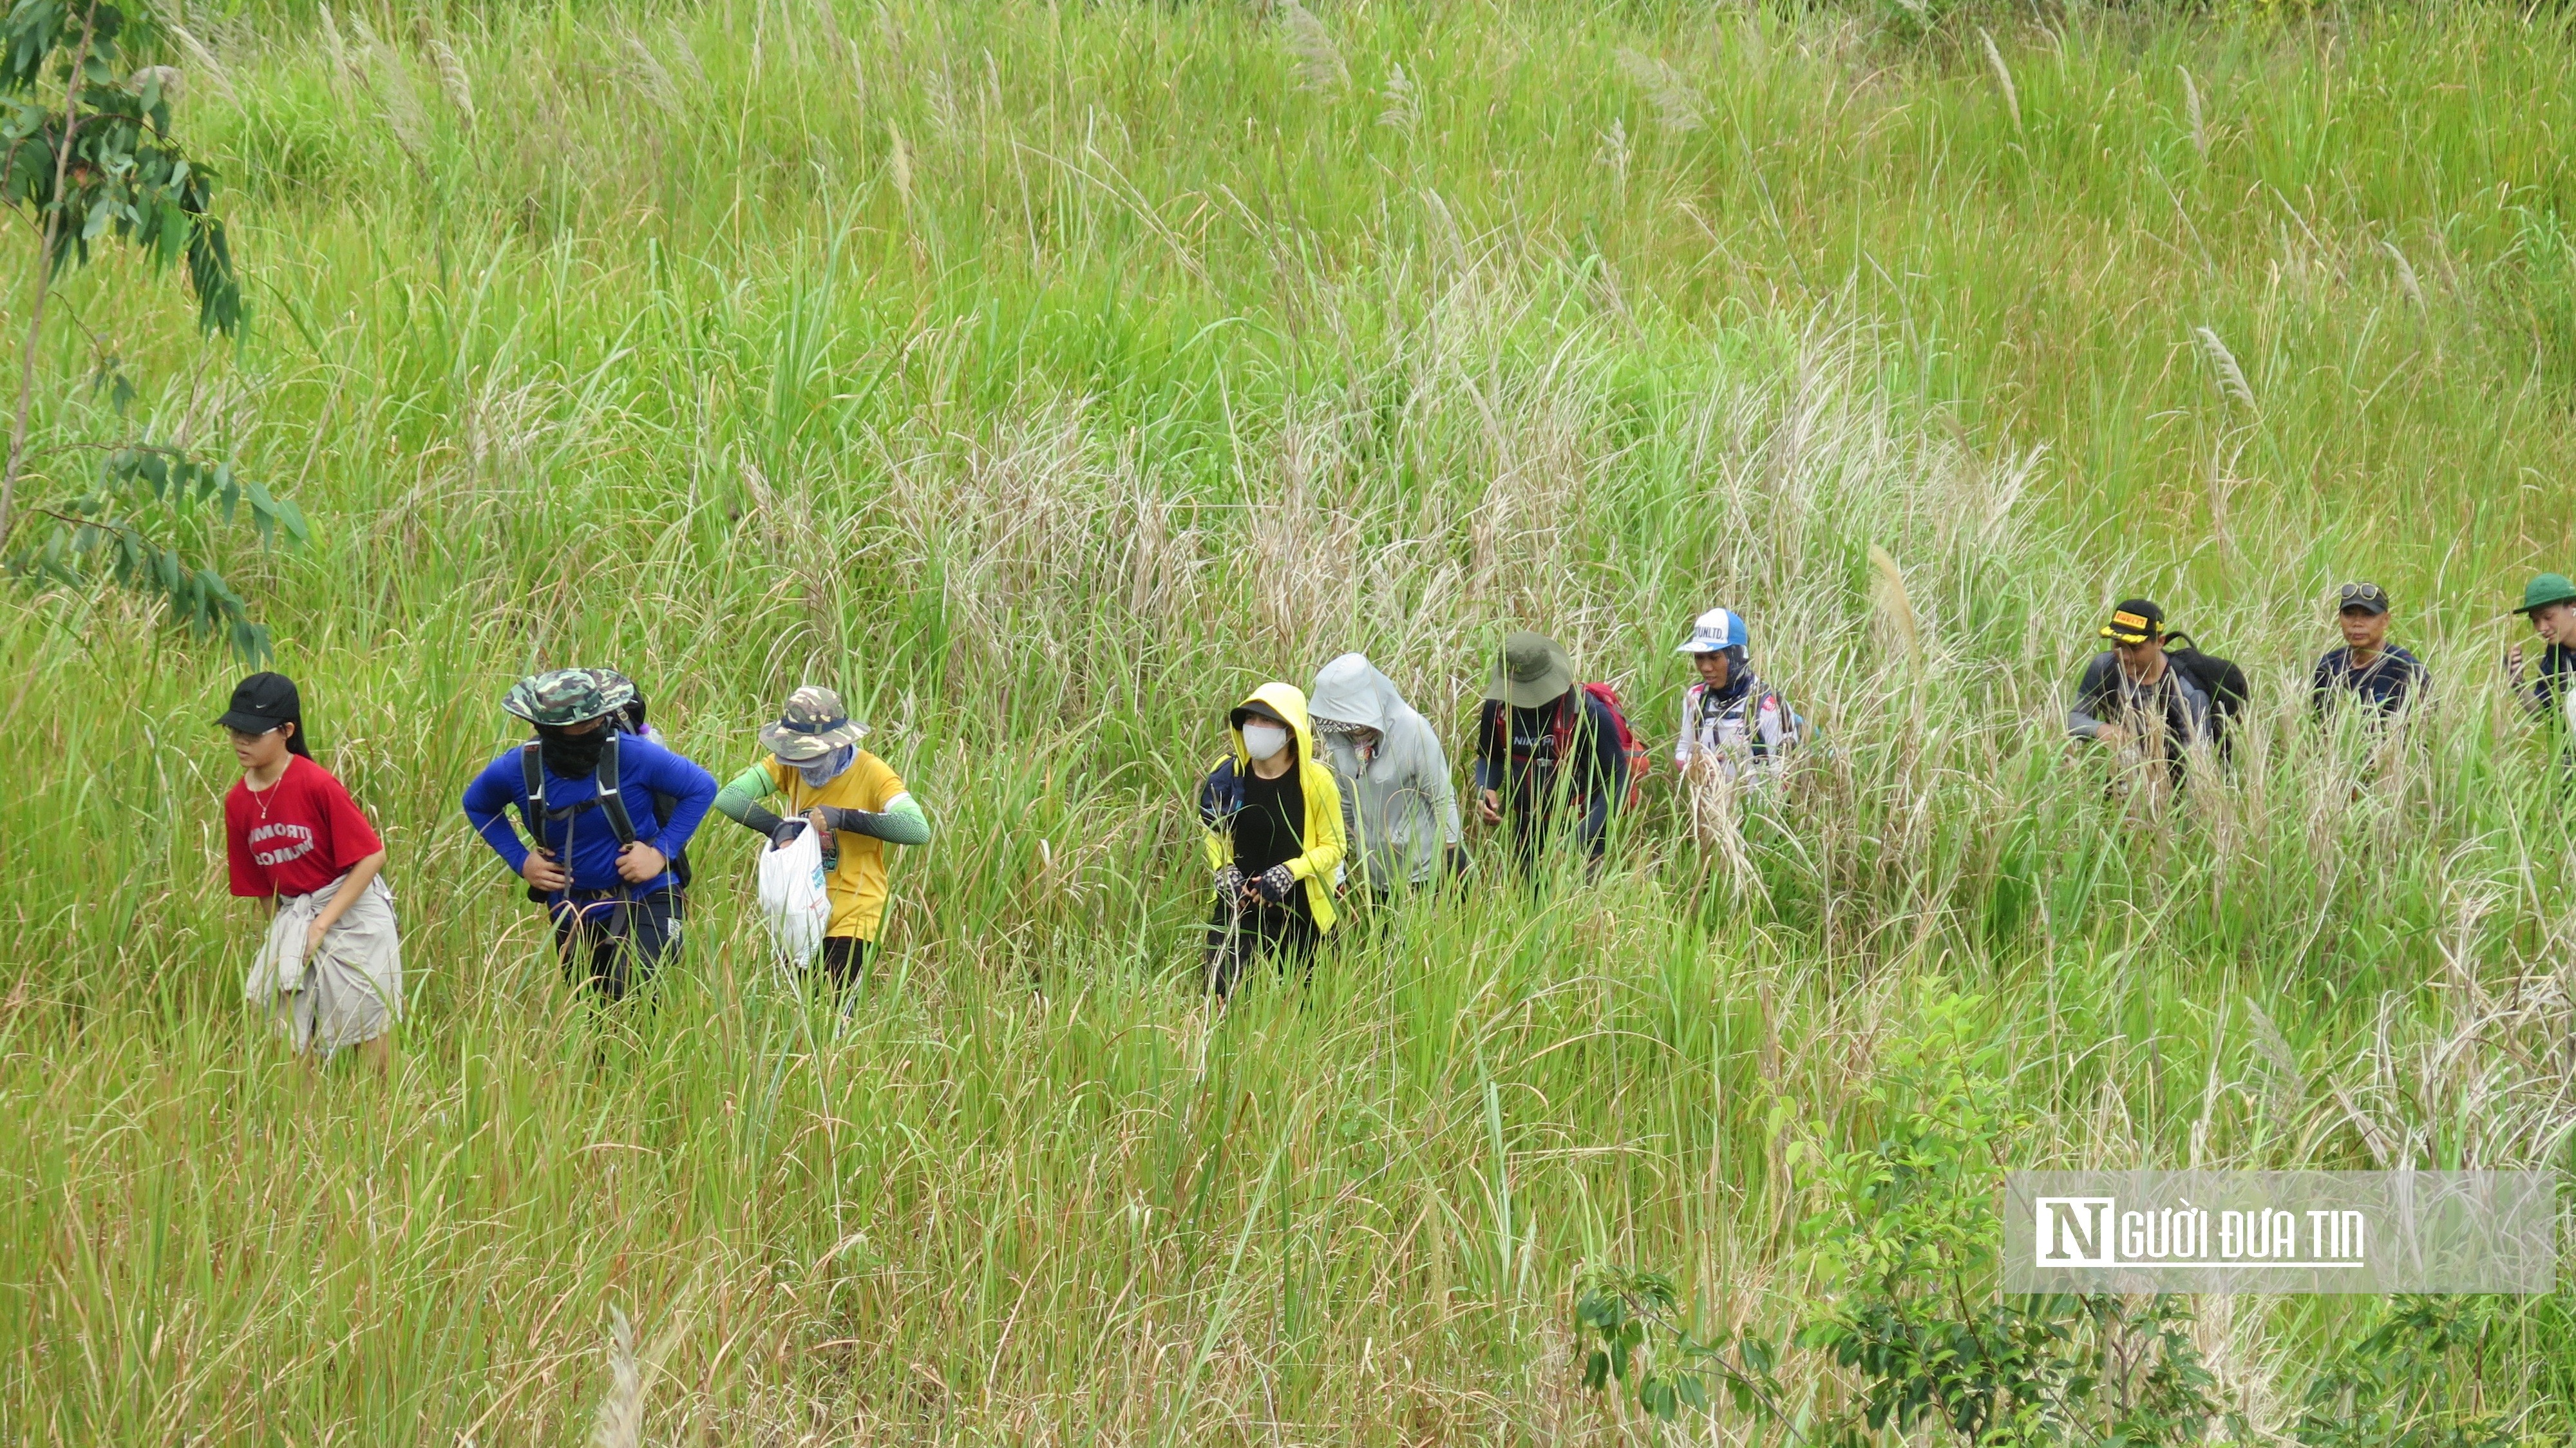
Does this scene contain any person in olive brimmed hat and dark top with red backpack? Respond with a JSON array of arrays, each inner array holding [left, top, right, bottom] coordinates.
[[1476, 629, 1628, 873]]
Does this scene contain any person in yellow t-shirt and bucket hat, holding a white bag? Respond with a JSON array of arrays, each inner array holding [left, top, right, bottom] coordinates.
[[716, 683, 930, 987]]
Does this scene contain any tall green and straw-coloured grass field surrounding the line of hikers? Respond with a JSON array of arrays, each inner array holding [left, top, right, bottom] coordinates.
[[0, 0, 2576, 1445]]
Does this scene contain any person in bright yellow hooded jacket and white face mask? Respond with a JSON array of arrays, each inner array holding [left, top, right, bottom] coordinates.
[[1198, 683, 1347, 1000]]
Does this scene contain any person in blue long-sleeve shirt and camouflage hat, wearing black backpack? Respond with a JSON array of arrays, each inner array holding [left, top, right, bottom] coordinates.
[[464, 670, 716, 1000]]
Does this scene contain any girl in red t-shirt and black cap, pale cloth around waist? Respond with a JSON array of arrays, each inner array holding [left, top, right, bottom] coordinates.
[[216, 672, 402, 1072]]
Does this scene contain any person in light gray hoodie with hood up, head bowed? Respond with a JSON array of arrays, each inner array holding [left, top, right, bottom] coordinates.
[[1306, 654, 1466, 897]]
